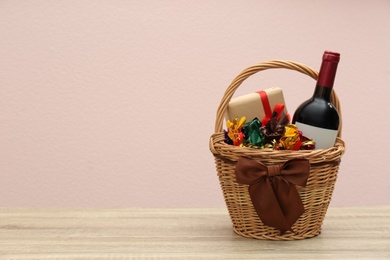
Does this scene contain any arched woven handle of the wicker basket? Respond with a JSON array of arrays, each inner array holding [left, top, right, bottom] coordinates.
[[215, 60, 342, 137]]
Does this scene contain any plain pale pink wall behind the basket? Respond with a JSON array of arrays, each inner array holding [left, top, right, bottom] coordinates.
[[0, 0, 390, 207]]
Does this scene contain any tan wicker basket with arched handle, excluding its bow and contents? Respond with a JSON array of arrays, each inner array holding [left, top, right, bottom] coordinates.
[[210, 60, 345, 240]]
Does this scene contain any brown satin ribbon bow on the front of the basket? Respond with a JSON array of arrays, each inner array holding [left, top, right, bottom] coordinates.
[[235, 157, 310, 235]]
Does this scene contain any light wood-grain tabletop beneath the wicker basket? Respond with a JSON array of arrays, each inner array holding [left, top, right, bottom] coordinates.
[[0, 207, 390, 260]]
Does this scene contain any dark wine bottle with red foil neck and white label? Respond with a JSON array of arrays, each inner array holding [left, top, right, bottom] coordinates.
[[292, 51, 340, 149]]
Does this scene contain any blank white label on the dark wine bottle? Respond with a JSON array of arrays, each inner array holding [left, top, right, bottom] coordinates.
[[295, 121, 338, 149]]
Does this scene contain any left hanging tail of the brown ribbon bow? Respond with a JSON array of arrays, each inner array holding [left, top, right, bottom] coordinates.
[[249, 179, 292, 235]]
